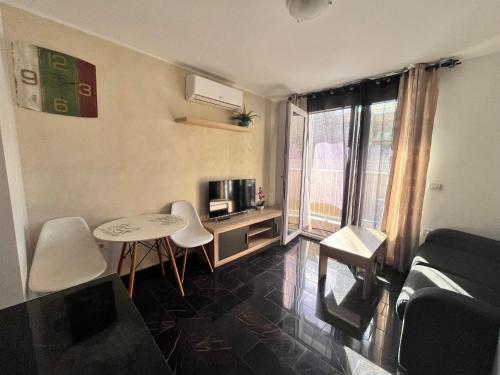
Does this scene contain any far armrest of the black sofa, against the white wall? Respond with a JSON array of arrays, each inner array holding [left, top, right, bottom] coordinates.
[[425, 229, 500, 261]]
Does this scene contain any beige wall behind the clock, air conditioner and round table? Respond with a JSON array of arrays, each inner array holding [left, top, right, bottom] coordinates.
[[2, 6, 275, 274]]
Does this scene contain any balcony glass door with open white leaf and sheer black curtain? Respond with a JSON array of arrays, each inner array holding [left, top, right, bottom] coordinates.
[[284, 80, 398, 243]]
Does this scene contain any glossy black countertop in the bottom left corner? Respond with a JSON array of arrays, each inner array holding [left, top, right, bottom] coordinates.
[[0, 275, 171, 375]]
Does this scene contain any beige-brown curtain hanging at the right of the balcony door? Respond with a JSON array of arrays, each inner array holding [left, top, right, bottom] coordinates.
[[381, 64, 438, 271]]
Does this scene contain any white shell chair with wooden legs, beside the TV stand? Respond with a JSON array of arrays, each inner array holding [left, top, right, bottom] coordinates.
[[170, 201, 214, 282]]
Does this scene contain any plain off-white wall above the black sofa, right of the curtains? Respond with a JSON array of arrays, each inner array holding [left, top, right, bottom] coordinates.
[[422, 53, 500, 240]]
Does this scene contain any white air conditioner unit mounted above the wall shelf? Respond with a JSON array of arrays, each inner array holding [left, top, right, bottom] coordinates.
[[186, 74, 243, 111]]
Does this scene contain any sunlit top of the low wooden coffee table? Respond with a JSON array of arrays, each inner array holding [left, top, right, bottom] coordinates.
[[320, 225, 387, 259]]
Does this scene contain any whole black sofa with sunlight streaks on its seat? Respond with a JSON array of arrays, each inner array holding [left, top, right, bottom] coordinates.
[[396, 229, 500, 375]]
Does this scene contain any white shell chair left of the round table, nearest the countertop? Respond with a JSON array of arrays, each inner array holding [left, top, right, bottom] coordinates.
[[28, 217, 106, 293]]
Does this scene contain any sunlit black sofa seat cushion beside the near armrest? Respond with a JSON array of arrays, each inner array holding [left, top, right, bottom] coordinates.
[[396, 264, 500, 319]]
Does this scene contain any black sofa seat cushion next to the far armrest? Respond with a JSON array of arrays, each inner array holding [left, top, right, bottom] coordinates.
[[413, 243, 500, 293]]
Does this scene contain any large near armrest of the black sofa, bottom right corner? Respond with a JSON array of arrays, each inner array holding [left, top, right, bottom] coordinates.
[[399, 288, 500, 375]]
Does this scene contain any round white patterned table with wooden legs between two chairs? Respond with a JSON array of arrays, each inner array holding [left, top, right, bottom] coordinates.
[[94, 214, 188, 297]]
